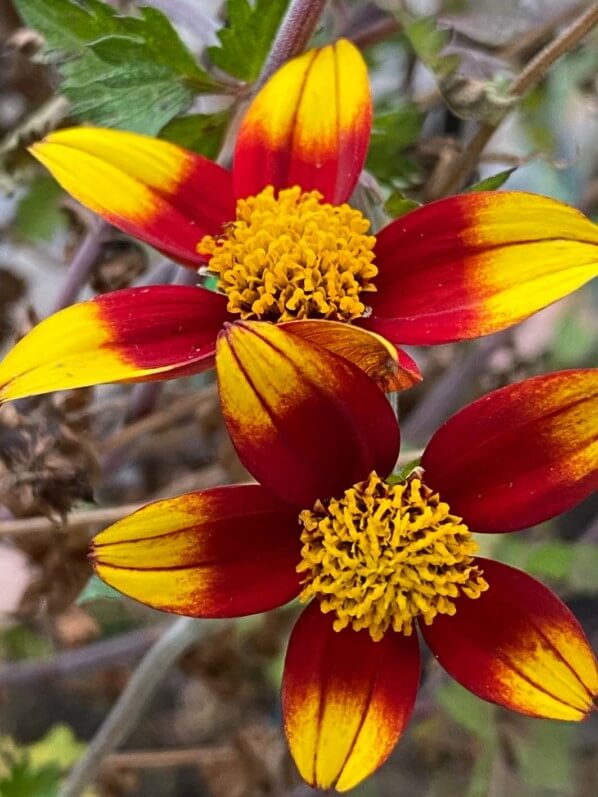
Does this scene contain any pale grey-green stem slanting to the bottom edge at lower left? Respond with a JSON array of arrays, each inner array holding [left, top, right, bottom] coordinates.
[[60, 617, 226, 797]]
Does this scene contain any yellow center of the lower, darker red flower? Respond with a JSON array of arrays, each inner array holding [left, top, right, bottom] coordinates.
[[297, 473, 488, 641]]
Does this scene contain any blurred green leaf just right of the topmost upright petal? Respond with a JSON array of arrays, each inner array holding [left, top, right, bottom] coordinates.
[[366, 103, 423, 189]]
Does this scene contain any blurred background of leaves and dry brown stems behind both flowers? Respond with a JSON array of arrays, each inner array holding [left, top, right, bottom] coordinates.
[[0, 0, 598, 797]]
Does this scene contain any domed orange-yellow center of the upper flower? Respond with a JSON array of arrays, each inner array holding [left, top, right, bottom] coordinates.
[[202, 186, 378, 321]]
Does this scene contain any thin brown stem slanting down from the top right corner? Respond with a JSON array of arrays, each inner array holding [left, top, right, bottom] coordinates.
[[431, 3, 598, 199]]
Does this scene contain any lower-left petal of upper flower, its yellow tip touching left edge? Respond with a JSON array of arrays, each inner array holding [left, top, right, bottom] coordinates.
[[0, 285, 228, 401]]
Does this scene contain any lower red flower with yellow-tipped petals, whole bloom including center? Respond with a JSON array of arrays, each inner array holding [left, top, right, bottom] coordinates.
[[92, 322, 598, 791]]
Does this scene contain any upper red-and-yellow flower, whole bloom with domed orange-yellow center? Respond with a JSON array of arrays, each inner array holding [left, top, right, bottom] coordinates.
[[0, 40, 598, 400]]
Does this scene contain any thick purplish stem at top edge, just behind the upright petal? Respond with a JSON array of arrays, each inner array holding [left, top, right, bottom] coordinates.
[[254, 0, 326, 91]]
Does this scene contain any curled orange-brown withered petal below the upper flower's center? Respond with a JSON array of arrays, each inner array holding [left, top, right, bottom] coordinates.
[[280, 320, 422, 392]]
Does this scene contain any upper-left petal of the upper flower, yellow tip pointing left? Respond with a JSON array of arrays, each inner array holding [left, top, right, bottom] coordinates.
[[30, 127, 235, 264]]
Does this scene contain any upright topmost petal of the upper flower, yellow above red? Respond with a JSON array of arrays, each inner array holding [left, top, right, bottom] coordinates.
[[233, 39, 372, 204]]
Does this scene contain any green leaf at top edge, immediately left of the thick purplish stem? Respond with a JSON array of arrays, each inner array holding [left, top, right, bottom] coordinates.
[[208, 0, 289, 83]]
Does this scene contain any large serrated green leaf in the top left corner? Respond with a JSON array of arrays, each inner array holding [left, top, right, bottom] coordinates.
[[15, 0, 217, 135]]
